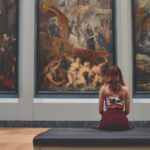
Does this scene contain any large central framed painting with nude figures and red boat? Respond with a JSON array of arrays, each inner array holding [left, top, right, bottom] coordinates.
[[35, 0, 115, 98]]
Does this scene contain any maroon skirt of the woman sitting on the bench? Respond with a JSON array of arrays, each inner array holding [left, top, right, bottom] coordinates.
[[96, 108, 129, 130]]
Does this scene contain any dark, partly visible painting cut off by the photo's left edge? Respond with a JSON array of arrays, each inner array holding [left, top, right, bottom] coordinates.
[[0, 0, 19, 95]]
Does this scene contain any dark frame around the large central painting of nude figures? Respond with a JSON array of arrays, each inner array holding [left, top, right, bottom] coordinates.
[[34, 0, 116, 98]]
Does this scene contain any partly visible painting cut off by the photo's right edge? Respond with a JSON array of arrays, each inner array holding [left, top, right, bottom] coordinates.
[[132, 0, 150, 94]]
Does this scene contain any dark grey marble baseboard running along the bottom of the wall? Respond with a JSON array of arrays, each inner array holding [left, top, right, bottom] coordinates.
[[0, 120, 150, 128]]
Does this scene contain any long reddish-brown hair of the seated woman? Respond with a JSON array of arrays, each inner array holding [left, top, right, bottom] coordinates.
[[105, 66, 125, 92]]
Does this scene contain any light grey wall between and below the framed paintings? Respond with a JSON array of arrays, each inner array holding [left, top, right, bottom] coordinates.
[[0, 0, 150, 121]]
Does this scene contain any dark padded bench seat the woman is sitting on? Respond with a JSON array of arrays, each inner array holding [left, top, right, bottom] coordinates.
[[33, 127, 150, 147]]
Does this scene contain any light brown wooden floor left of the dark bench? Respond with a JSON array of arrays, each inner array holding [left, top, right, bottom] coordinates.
[[0, 128, 48, 150]]
